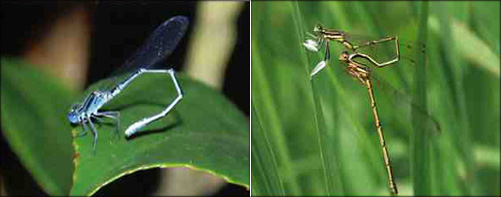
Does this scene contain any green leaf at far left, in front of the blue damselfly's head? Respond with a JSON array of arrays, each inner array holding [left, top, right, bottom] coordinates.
[[0, 57, 74, 195]]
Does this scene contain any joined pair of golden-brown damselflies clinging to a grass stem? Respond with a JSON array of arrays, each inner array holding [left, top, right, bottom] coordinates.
[[303, 25, 440, 195]]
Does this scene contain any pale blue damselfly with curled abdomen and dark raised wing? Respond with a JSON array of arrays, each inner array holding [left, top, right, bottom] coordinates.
[[67, 16, 188, 152]]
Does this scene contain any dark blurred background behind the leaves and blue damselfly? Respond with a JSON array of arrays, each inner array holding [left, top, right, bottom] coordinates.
[[0, 1, 250, 196]]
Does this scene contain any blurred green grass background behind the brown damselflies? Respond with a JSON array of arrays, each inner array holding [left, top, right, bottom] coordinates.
[[251, 1, 500, 195]]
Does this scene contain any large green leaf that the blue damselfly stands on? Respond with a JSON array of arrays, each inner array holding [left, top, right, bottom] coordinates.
[[70, 68, 250, 195]]
